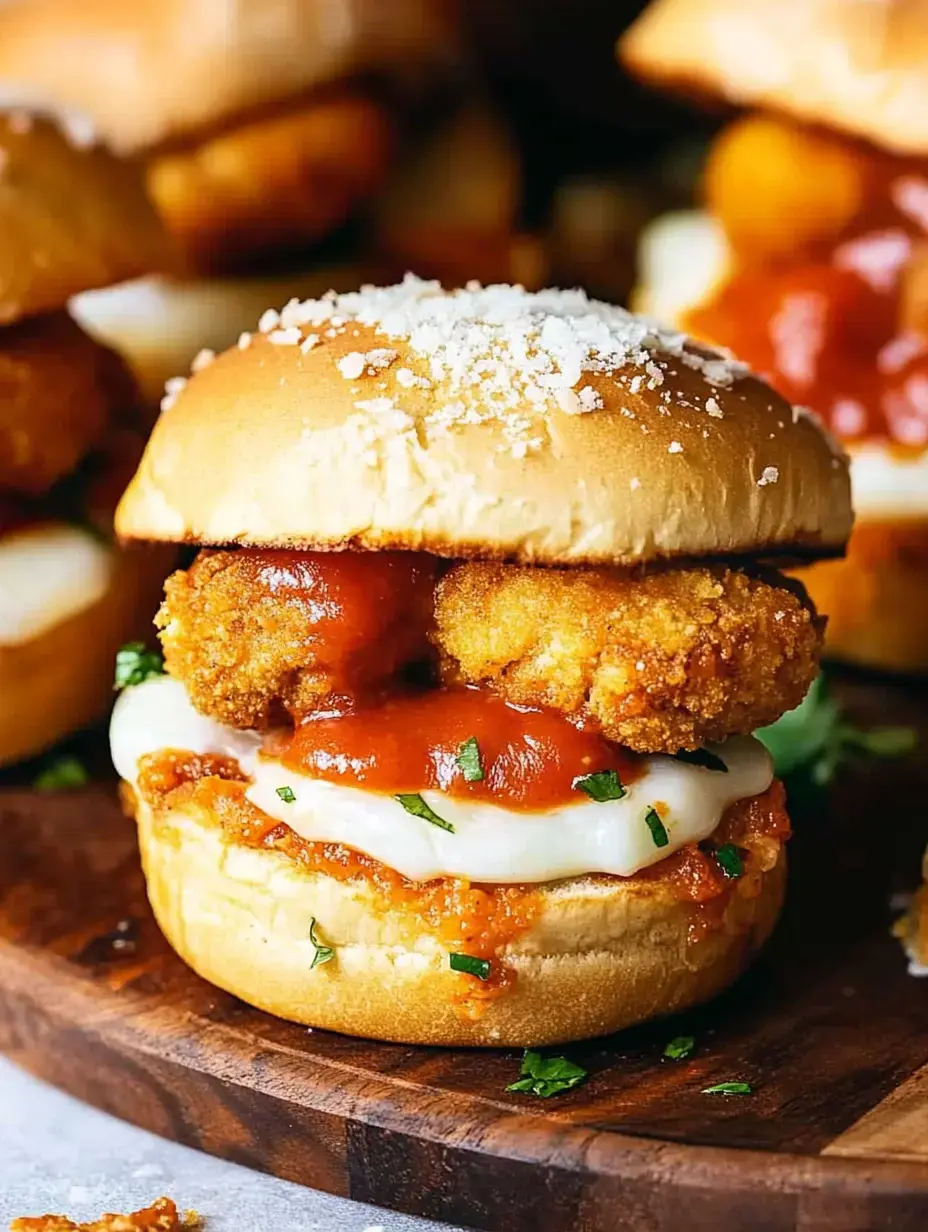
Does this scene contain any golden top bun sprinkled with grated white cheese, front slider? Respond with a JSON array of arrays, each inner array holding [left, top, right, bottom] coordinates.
[[116, 277, 852, 564]]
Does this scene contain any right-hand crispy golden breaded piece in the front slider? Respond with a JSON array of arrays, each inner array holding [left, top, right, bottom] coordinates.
[[434, 563, 824, 753]]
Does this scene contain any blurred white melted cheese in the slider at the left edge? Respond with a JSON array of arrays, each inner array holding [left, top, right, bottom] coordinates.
[[0, 522, 112, 646]]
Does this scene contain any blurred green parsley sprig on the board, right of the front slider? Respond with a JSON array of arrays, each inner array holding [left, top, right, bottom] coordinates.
[[754, 674, 918, 787]]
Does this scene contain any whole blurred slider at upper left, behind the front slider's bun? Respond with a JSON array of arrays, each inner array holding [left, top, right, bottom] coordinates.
[[0, 0, 454, 407]]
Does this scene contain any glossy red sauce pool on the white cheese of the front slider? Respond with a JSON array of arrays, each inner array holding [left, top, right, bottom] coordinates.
[[269, 689, 640, 811]]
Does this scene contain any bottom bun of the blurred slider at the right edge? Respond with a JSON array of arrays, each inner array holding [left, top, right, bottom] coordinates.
[[796, 519, 928, 673]]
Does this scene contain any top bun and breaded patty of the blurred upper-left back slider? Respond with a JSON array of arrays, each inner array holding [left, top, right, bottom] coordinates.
[[0, 0, 449, 272]]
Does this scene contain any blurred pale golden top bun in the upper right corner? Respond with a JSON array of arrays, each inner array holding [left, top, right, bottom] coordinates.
[[619, 0, 928, 154]]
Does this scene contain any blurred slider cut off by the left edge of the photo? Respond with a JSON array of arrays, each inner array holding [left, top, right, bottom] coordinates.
[[0, 111, 168, 765]]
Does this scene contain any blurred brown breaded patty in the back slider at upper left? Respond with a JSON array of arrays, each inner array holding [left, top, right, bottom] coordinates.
[[148, 91, 394, 272]]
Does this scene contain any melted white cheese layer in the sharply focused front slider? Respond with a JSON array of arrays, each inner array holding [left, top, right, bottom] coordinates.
[[110, 676, 773, 882]]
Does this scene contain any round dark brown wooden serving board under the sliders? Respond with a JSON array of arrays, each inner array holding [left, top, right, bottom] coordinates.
[[0, 684, 928, 1232]]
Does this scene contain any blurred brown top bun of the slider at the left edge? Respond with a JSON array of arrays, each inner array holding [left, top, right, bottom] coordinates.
[[0, 111, 170, 325]]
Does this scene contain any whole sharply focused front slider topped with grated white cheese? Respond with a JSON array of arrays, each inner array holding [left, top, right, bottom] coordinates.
[[111, 277, 852, 1045]]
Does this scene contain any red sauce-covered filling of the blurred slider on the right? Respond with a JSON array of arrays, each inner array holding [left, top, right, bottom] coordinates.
[[684, 121, 928, 448]]
